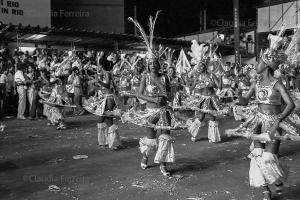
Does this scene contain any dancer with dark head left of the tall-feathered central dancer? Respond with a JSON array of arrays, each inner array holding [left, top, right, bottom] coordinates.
[[83, 55, 122, 150]]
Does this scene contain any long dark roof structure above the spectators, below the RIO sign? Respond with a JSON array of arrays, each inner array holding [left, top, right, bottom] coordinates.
[[0, 24, 234, 55]]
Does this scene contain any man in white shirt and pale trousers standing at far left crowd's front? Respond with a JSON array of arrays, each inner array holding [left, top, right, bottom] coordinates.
[[15, 65, 27, 119]]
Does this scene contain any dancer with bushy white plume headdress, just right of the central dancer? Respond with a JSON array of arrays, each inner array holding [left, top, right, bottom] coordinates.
[[179, 41, 223, 142]]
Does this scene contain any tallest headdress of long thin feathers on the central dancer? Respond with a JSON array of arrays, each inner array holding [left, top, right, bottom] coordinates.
[[128, 11, 161, 59]]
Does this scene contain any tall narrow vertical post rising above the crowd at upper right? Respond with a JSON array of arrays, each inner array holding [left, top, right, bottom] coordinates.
[[233, 0, 241, 63]]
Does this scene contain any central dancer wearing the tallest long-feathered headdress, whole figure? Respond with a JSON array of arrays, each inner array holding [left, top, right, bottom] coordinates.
[[122, 12, 186, 176]]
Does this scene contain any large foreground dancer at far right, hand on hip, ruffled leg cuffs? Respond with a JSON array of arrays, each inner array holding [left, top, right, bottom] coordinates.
[[226, 30, 298, 200]]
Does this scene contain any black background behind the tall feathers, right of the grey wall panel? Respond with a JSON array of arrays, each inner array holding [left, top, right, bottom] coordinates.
[[125, 0, 265, 37]]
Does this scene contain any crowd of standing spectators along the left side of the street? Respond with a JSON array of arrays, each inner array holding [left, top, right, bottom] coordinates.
[[0, 48, 110, 120]]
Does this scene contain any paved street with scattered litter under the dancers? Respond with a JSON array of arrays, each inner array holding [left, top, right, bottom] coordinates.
[[0, 115, 300, 200]]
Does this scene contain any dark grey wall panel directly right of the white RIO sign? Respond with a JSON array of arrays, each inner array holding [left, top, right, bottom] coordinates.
[[51, 0, 125, 33]]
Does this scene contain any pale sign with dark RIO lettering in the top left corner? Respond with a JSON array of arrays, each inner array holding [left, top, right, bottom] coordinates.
[[0, 0, 51, 27]]
